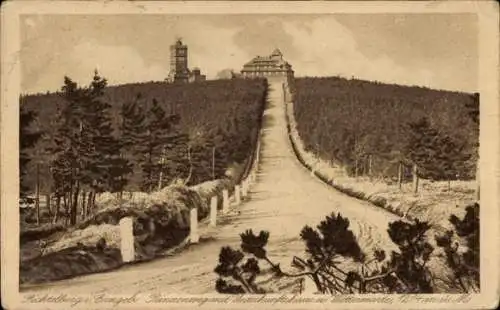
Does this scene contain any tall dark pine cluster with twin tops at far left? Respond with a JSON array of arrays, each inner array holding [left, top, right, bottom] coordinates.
[[47, 72, 127, 225]]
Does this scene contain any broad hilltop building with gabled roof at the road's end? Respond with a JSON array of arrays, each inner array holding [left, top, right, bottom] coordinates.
[[241, 49, 294, 82]]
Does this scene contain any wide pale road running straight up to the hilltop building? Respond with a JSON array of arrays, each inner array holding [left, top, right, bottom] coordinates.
[[24, 83, 397, 294]]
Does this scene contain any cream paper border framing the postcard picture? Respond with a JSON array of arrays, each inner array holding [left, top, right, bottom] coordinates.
[[0, 1, 500, 309]]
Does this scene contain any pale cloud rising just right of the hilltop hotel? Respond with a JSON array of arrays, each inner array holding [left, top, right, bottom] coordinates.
[[283, 17, 433, 85]]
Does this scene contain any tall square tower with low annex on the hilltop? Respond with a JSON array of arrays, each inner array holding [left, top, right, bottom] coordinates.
[[166, 39, 206, 83]]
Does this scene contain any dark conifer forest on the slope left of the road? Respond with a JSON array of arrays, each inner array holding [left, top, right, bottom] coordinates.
[[20, 71, 267, 225]]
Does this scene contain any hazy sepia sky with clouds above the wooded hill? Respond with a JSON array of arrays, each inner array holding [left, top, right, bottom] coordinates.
[[20, 13, 478, 93]]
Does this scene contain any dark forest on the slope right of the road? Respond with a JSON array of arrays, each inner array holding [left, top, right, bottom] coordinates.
[[293, 77, 479, 181]]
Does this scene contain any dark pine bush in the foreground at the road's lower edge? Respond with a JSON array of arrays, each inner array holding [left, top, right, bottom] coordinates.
[[214, 214, 434, 294]]
